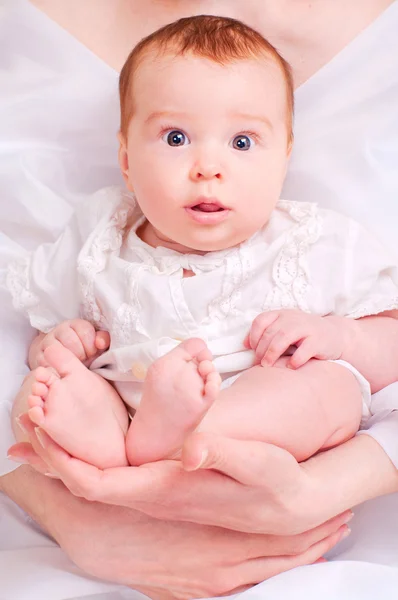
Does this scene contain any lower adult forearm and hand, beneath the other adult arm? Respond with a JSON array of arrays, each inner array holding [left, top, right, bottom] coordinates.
[[0, 467, 350, 600]]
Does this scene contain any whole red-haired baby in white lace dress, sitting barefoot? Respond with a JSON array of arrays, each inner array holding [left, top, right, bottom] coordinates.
[[8, 16, 398, 469]]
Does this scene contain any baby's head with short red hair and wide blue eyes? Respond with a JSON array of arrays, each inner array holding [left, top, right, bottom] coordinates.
[[119, 15, 293, 252]]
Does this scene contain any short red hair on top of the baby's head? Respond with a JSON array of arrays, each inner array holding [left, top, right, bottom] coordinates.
[[119, 15, 294, 139]]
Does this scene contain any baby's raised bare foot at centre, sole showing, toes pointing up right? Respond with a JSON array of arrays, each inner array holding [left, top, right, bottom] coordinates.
[[127, 339, 221, 465]]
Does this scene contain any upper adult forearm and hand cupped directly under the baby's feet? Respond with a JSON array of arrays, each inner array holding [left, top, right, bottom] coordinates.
[[11, 417, 398, 535]]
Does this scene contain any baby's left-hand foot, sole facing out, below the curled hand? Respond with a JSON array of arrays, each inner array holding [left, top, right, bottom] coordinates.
[[28, 343, 128, 469]]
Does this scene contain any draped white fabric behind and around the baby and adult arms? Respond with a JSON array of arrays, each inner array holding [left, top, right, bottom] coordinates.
[[0, 0, 398, 600]]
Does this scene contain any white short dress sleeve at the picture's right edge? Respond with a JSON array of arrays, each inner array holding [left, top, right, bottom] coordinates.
[[329, 219, 398, 319]]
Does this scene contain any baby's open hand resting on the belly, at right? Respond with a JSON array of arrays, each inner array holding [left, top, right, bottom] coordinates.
[[245, 310, 345, 369]]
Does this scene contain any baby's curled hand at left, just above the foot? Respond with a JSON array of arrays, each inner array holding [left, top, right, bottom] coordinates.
[[37, 319, 110, 366]]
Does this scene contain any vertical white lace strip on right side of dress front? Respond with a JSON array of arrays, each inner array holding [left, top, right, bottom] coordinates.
[[263, 200, 322, 312]]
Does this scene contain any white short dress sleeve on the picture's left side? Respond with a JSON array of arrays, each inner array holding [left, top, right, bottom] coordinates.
[[6, 193, 110, 333]]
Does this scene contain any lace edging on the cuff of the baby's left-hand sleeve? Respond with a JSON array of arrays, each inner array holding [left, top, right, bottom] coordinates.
[[6, 256, 57, 333]]
